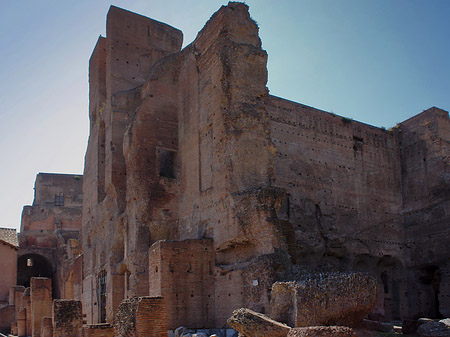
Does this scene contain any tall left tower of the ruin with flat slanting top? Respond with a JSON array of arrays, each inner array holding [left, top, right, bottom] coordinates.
[[82, 6, 182, 323]]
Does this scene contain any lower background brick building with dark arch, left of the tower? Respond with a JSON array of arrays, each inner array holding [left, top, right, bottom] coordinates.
[[17, 173, 83, 297]]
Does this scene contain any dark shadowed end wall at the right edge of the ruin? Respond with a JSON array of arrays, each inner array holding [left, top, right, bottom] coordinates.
[[396, 108, 450, 317]]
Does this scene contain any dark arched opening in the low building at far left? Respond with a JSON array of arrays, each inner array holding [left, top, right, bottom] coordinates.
[[17, 254, 53, 288]]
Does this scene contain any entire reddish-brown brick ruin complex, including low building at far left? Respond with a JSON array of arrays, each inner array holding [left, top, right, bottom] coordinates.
[[0, 2, 450, 336]]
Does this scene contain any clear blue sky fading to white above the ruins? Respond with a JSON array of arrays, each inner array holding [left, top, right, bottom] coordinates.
[[0, 0, 450, 228]]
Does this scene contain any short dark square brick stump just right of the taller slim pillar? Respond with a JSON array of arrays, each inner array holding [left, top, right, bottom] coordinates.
[[53, 300, 83, 337]]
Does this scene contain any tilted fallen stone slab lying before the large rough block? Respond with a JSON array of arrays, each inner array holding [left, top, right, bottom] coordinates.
[[227, 308, 291, 337]]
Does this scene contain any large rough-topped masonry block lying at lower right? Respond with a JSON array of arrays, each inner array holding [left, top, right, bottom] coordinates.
[[270, 272, 377, 327]]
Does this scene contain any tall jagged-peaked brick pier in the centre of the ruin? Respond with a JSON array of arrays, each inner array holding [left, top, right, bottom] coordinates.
[[174, 3, 285, 327]]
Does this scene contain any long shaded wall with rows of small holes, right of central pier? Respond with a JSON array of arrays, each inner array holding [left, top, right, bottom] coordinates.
[[267, 96, 404, 269]]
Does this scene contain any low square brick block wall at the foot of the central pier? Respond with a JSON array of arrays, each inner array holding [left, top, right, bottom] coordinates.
[[149, 240, 215, 330]]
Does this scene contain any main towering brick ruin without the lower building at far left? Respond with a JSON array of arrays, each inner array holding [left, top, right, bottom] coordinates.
[[79, 3, 450, 327]]
